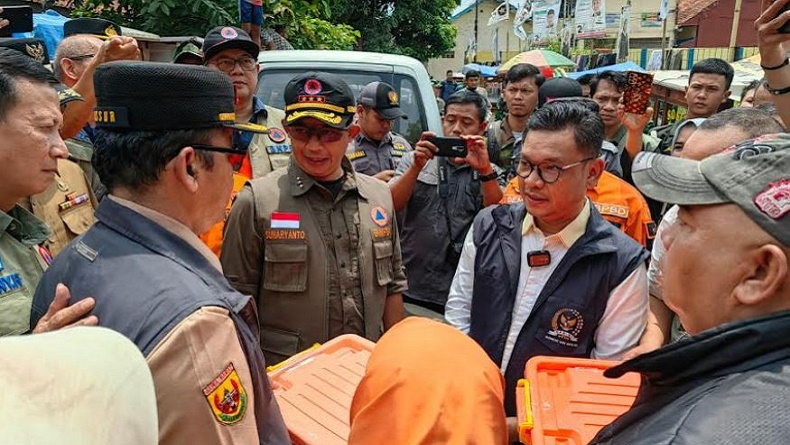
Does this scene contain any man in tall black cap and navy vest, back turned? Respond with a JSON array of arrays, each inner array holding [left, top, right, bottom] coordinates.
[[31, 62, 290, 445]]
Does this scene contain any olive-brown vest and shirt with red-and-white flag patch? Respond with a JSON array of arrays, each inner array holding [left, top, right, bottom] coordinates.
[[220, 158, 406, 364]]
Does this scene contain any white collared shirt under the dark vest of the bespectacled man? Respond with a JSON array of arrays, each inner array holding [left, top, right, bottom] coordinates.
[[445, 200, 648, 372]]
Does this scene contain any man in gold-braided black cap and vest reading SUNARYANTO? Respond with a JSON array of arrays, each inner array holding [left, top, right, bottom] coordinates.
[[220, 72, 406, 363]]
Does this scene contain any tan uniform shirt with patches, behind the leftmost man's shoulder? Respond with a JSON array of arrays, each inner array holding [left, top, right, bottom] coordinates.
[[19, 159, 98, 256]]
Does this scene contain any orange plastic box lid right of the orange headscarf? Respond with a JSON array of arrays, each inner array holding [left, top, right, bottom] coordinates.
[[516, 356, 640, 445]]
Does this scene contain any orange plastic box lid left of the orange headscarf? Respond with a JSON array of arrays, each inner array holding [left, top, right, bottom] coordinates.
[[268, 335, 375, 445]]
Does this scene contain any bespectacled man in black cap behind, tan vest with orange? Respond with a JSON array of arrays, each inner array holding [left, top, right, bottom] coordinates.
[[200, 26, 292, 256]]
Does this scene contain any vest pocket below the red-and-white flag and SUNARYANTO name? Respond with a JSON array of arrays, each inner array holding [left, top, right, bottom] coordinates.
[[263, 241, 307, 292]]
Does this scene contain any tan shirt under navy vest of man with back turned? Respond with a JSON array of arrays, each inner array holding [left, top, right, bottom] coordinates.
[[109, 196, 258, 445]]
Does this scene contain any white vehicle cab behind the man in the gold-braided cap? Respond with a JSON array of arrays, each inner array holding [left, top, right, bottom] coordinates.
[[256, 50, 442, 144]]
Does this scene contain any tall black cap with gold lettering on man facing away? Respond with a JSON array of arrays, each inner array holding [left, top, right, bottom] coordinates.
[[93, 61, 268, 133]]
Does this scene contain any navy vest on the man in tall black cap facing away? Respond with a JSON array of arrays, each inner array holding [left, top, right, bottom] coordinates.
[[31, 199, 290, 445]]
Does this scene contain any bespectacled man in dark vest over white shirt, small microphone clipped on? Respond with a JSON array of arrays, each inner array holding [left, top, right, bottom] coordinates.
[[446, 101, 648, 424]]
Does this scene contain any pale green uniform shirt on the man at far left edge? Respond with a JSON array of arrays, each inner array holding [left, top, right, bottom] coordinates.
[[0, 205, 52, 336]]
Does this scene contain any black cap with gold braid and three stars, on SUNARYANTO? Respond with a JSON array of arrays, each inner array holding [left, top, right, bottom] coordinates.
[[283, 71, 356, 129]]
